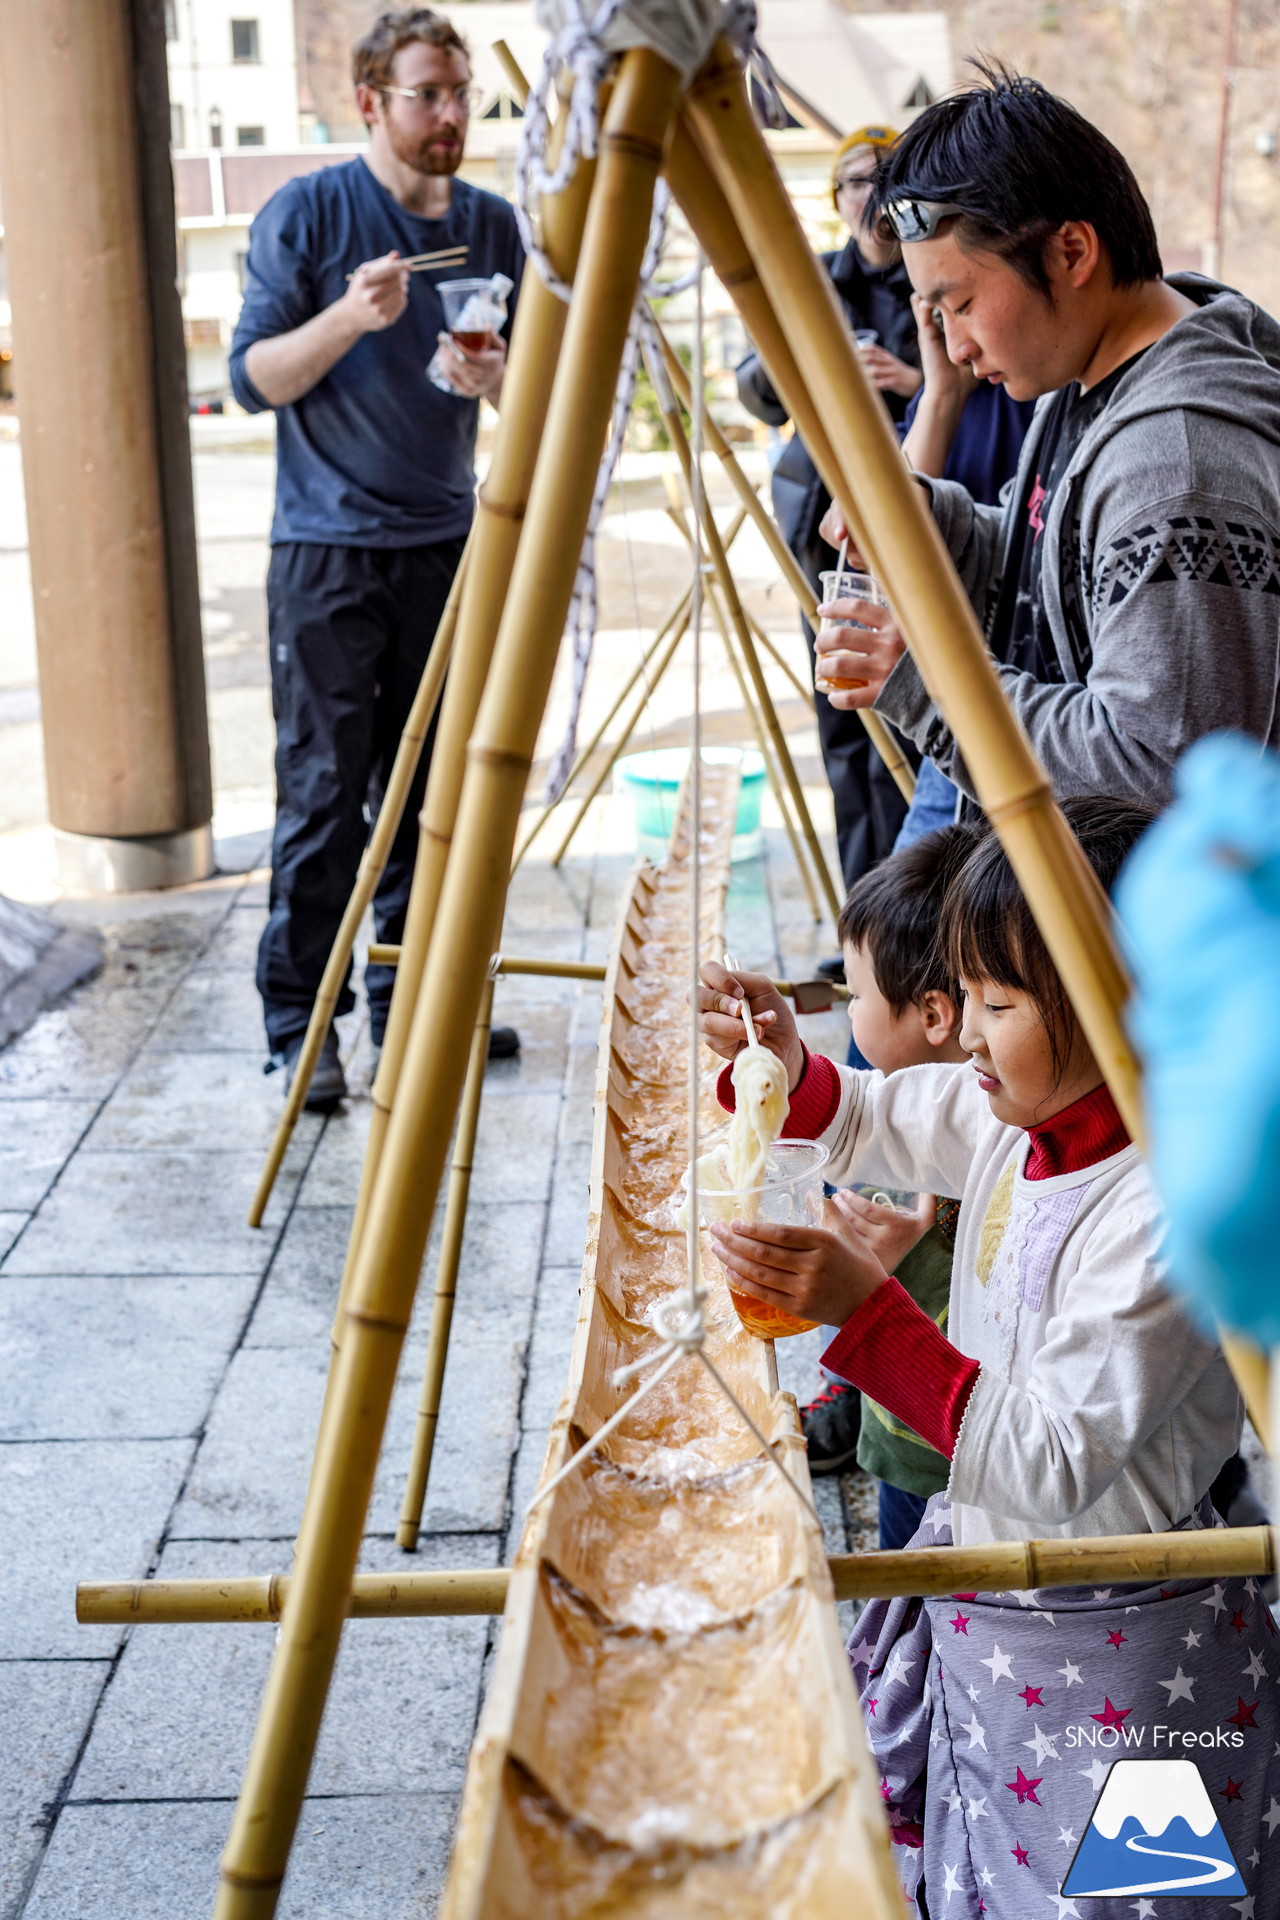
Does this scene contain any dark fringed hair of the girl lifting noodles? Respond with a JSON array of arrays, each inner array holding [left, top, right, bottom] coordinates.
[[940, 797, 1155, 1077]]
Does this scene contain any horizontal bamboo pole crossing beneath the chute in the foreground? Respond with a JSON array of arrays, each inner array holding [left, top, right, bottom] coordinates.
[[75, 1526, 1276, 1626]]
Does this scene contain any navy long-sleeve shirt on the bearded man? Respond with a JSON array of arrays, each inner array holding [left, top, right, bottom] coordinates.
[[230, 159, 524, 547]]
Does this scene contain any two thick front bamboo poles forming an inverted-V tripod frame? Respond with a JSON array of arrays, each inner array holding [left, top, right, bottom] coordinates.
[[102, 42, 1261, 1920]]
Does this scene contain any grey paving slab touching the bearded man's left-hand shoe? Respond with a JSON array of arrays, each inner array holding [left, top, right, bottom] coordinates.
[[87, 1046, 322, 1152]]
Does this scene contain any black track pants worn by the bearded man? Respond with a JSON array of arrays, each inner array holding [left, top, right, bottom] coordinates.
[[257, 540, 462, 1050]]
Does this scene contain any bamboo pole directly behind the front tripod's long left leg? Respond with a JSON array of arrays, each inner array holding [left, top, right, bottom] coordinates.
[[320, 88, 608, 1367]]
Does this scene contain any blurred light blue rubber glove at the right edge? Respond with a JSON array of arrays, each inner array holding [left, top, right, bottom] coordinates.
[[1115, 733, 1280, 1346]]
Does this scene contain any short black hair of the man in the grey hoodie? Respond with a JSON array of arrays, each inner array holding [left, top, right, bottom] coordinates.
[[867, 60, 1165, 298]]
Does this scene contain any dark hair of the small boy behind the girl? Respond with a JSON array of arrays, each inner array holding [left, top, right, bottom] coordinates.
[[837, 828, 975, 1014]]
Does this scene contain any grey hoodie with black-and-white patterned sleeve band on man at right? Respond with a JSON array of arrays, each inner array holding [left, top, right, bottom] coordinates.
[[875, 275, 1280, 804]]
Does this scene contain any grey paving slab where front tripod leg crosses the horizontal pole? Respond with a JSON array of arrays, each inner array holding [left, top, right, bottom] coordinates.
[[75, 1540, 495, 1801]]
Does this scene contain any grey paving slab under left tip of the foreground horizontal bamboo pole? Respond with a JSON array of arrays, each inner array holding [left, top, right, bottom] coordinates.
[[0, 1440, 192, 1659]]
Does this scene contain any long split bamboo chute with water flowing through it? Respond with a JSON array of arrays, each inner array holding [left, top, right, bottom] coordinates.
[[441, 766, 900, 1920]]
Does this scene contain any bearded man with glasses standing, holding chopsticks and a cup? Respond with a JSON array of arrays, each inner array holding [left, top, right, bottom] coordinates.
[[230, 8, 524, 1112]]
